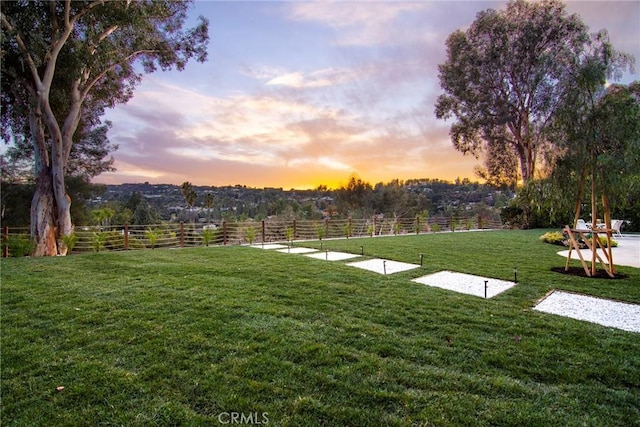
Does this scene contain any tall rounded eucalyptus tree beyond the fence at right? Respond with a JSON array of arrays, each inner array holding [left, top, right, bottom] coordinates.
[[436, 0, 589, 185]]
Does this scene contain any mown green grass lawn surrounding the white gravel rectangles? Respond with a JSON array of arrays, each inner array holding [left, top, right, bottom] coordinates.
[[0, 230, 640, 426]]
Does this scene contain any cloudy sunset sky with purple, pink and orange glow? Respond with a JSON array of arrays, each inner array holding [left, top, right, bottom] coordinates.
[[96, 0, 640, 189]]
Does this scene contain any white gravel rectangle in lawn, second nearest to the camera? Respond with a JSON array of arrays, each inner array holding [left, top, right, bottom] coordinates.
[[412, 271, 515, 298]]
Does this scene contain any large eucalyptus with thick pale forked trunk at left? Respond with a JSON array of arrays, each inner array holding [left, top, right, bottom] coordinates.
[[0, 0, 208, 255]]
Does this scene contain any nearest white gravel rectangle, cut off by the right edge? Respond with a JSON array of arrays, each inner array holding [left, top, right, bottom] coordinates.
[[534, 291, 640, 332]]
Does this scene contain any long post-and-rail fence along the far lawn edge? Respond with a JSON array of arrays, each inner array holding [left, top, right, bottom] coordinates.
[[1, 216, 503, 257]]
